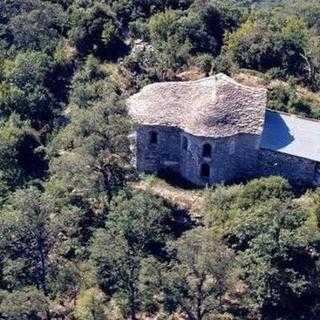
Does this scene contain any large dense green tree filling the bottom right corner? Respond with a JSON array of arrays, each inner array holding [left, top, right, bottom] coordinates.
[[232, 200, 320, 319]]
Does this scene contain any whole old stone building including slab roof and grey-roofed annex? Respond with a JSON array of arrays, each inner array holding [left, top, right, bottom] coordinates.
[[127, 74, 320, 186]]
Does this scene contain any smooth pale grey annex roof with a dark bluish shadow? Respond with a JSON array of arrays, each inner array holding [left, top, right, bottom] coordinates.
[[260, 110, 320, 162]]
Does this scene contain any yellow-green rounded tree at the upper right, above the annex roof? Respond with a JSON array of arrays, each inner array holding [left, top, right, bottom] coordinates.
[[226, 12, 319, 87]]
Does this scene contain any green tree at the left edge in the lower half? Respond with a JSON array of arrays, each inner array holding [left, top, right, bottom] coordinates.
[[0, 188, 54, 293]]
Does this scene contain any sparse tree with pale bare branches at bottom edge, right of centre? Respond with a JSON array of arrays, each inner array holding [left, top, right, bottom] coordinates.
[[164, 229, 233, 320]]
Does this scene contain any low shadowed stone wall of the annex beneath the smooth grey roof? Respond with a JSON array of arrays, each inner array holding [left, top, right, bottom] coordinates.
[[258, 149, 316, 186]]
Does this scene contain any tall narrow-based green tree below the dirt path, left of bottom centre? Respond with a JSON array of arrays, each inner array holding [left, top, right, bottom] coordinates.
[[91, 193, 169, 319]]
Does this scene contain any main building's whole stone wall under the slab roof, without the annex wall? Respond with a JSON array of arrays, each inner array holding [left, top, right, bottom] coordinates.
[[135, 126, 259, 185]]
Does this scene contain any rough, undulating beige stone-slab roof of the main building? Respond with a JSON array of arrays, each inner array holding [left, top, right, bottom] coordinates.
[[127, 74, 266, 137]]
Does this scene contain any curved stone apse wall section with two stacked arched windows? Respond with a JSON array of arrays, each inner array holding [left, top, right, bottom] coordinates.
[[180, 133, 259, 185]]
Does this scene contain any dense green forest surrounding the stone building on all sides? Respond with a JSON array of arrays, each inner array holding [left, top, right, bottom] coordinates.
[[0, 0, 320, 320]]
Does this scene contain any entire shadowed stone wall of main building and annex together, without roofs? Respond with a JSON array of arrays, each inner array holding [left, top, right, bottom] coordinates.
[[135, 126, 316, 186]]
